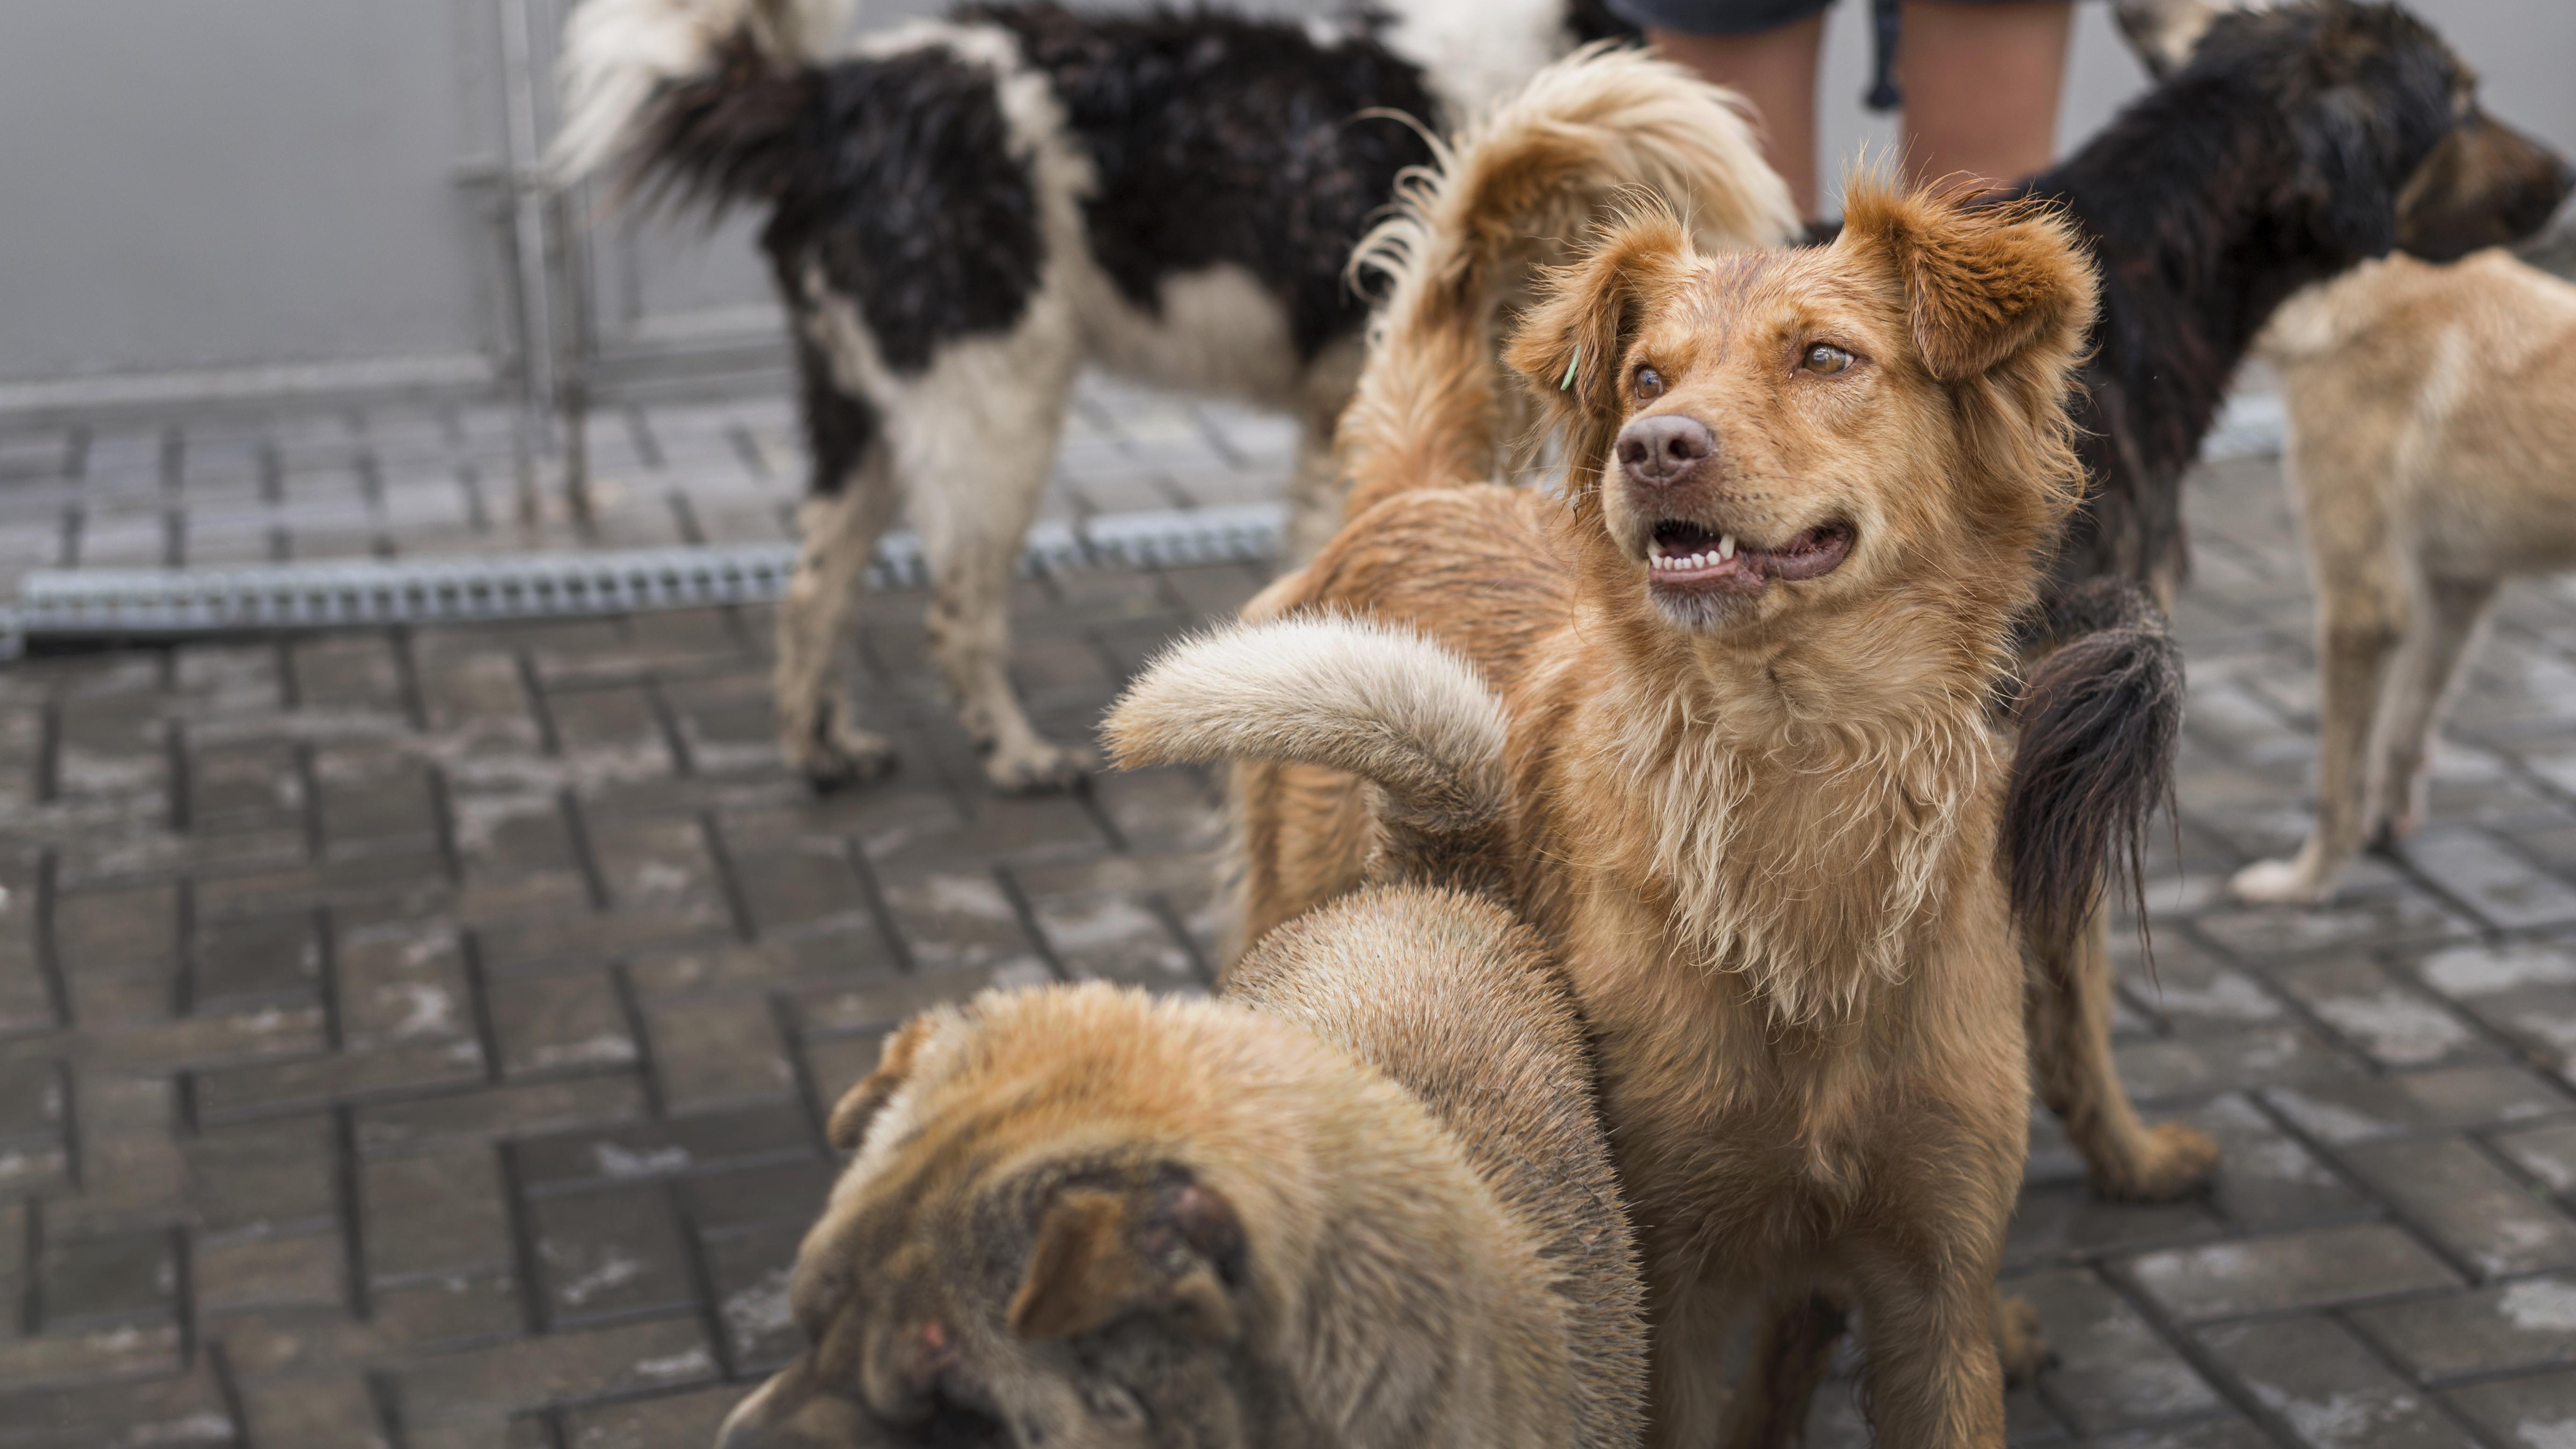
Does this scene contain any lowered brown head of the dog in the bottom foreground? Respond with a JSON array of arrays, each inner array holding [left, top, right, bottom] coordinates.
[[719, 998, 1247, 1449]]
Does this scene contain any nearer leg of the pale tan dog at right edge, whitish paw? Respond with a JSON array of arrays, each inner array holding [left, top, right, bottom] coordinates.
[[2228, 570, 2411, 902]]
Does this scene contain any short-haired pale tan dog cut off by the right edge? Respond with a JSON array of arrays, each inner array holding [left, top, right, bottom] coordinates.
[[2231, 250, 2576, 900]]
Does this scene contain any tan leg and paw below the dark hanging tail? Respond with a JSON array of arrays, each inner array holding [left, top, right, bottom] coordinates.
[[2027, 905, 2218, 1201]]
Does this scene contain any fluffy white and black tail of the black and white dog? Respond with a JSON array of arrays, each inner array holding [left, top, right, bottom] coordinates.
[[549, 0, 853, 206]]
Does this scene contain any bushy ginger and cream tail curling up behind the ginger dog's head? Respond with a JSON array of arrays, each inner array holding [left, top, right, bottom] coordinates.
[[1340, 41, 1798, 518]]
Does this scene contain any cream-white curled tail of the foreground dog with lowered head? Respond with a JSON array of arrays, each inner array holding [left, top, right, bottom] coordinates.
[[1100, 614, 1507, 892]]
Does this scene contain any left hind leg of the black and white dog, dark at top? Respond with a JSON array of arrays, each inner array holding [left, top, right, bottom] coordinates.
[[775, 338, 897, 791]]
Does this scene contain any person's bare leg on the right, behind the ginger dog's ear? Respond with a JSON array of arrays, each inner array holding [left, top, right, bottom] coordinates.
[[1896, 0, 2074, 186]]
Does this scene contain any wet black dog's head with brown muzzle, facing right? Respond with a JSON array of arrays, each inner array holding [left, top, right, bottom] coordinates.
[[2117, 0, 2576, 260]]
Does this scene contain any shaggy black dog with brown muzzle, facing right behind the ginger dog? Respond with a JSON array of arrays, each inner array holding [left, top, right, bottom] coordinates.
[[2014, 0, 2571, 601]]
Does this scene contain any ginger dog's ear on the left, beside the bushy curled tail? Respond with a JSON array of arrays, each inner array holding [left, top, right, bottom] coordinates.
[[1504, 206, 1695, 467]]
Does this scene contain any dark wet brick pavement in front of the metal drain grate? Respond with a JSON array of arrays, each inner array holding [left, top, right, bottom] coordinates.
[[0, 387, 2576, 1449]]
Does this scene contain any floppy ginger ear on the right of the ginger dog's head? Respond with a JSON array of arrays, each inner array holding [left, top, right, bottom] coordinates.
[[1834, 183, 2094, 381]]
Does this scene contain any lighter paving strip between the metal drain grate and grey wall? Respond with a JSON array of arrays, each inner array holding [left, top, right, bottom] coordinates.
[[0, 379, 1296, 593]]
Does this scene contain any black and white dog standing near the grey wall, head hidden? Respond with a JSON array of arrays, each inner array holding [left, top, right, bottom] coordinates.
[[556, 0, 1790, 791]]
